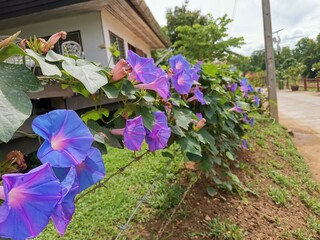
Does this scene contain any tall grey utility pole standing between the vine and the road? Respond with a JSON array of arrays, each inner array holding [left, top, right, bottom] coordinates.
[[261, 0, 279, 122]]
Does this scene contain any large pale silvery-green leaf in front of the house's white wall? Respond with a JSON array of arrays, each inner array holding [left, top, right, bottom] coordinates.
[[62, 59, 108, 94]]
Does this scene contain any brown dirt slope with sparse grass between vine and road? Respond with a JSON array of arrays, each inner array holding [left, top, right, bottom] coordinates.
[[130, 115, 320, 240]]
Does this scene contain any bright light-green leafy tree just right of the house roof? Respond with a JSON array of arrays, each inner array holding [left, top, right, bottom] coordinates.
[[165, 1, 244, 60]]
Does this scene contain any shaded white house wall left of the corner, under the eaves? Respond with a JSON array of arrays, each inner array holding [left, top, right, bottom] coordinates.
[[0, 11, 109, 66]]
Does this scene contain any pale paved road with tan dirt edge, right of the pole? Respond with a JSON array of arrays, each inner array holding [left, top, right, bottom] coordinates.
[[278, 90, 320, 182]]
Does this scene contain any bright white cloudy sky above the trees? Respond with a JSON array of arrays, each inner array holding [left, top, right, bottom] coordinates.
[[145, 0, 320, 56]]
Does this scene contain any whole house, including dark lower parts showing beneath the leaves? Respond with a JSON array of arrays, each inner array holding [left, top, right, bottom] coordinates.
[[0, 0, 170, 156]]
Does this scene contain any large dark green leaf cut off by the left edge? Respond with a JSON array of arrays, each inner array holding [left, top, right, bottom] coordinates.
[[0, 62, 43, 142]]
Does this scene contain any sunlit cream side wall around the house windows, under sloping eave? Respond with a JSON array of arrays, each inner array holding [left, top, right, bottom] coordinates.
[[101, 9, 151, 64]]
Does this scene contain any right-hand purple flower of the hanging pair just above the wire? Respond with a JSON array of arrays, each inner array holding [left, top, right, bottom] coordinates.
[[146, 112, 171, 152]]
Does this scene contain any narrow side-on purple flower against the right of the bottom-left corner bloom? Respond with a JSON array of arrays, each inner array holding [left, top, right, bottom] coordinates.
[[51, 167, 79, 236]]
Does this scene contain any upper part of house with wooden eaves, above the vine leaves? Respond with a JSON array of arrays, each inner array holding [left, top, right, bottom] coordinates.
[[0, 0, 170, 66]]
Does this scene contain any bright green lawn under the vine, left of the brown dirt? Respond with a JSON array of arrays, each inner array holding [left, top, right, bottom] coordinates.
[[37, 145, 183, 240]]
